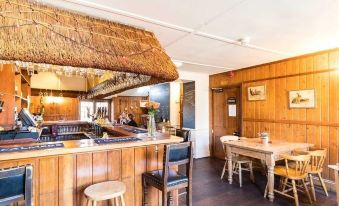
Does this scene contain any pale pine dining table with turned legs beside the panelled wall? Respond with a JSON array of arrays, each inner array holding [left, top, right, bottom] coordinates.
[[224, 138, 313, 202]]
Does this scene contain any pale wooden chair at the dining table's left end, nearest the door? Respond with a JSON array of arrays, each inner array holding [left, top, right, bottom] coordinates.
[[220, 136, 254, 187]]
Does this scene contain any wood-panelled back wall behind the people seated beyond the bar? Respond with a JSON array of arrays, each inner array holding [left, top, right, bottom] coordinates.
[[112, 96, 148, 124]]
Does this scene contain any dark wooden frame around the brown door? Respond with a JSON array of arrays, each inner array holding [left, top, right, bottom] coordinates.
[[210, 83, 243, 157]]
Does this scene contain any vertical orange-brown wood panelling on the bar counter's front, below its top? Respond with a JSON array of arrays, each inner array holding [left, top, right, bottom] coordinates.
[[0, 145, 178, 206]]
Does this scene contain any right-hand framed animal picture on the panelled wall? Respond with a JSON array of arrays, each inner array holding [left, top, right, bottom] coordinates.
[[288, 89, 315, 108]]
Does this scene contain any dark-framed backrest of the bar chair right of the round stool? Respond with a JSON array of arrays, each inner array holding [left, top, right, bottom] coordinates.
[[163, 142, 193, 185]]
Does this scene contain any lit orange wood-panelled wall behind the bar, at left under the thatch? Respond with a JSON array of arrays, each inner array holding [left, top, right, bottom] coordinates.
[[30, 96, 80, 121]]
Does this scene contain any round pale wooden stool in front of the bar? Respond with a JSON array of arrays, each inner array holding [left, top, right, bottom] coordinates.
[[84, 181, 126, 206]]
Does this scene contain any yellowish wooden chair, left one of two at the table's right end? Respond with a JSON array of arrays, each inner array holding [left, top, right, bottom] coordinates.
[[264, 155, 312, 206]]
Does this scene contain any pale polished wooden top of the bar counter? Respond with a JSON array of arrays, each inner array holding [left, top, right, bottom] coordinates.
[[0, 126, 183, 161]]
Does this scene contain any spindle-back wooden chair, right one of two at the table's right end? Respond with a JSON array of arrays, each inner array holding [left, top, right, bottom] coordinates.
[[306, 149, 328, 201]]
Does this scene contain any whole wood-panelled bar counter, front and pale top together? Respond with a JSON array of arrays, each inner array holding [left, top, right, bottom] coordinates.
[[0, 126, 182, 206]]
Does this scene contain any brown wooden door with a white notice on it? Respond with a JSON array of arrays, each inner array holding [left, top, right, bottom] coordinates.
[[211, 85, 242, 159]]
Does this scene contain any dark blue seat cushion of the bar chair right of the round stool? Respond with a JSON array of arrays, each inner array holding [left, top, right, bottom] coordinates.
[[144, 170, 188, 187]]
